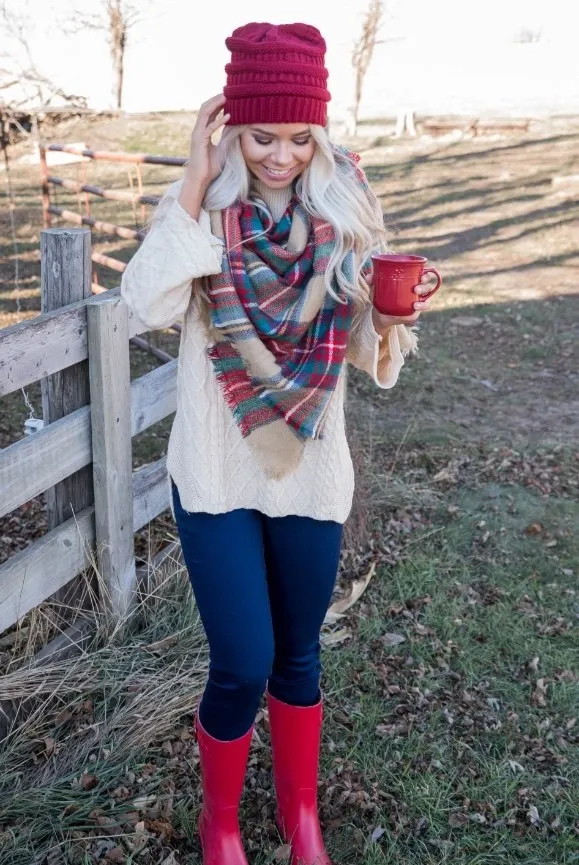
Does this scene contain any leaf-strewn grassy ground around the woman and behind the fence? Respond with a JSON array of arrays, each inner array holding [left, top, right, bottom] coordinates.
[[0, 117, 579, 865]]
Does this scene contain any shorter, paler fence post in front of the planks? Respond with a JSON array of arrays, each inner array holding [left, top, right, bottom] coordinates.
[[87, 296, 136, 617]]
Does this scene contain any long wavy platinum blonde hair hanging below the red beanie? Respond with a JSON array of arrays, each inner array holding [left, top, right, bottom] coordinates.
[[203, 125, 388, 307]]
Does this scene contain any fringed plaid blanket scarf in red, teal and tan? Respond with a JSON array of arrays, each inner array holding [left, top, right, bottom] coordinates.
[[207, 159, 372, 478]]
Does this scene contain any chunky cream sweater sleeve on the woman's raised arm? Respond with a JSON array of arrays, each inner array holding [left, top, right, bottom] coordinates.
[[121, 181, 223, 330]]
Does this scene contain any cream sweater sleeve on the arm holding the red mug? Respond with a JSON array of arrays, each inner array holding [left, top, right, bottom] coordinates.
[[346, 305, 417, 389]]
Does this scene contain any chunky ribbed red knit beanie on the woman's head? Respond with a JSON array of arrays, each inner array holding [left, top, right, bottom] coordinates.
[[223, 23, 330, 126]]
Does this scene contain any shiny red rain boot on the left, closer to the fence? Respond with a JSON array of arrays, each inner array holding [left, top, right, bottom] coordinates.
[[195, 715, 253, 865]]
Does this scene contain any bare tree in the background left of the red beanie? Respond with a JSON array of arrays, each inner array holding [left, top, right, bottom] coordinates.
[[63, 0, 144, 109]]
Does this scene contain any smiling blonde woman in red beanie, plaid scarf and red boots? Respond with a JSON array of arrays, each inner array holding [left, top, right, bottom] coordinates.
[[121, 23, 428, 865]]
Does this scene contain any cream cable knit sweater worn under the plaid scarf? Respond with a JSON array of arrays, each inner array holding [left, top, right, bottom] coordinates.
[[121, 181, 415, 523]]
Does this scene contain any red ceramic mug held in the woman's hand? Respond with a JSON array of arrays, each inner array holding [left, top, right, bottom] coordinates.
[[372, 255, 442, 315]]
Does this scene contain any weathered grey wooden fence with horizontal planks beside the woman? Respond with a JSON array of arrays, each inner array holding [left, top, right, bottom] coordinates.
[[0, 229, 177, 632]]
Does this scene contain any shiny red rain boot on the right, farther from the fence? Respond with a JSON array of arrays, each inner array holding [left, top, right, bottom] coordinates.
[[267, 692, 331, 865]]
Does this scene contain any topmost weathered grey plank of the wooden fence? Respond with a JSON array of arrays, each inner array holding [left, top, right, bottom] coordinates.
[[0, 288, 149, 396]]
